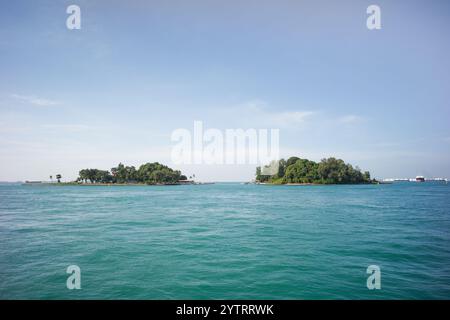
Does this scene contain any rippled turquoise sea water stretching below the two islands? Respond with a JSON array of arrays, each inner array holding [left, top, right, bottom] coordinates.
[[0, 183, 450, 299]]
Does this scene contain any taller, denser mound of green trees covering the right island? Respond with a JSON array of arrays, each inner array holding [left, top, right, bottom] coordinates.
[[256, 157, 374, 184]]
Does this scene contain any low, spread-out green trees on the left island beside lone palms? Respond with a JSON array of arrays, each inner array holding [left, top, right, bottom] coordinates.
[[77, 162, 187, 184]]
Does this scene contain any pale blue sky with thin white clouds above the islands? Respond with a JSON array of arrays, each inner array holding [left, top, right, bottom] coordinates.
[[0, 0, 450, 181]]
